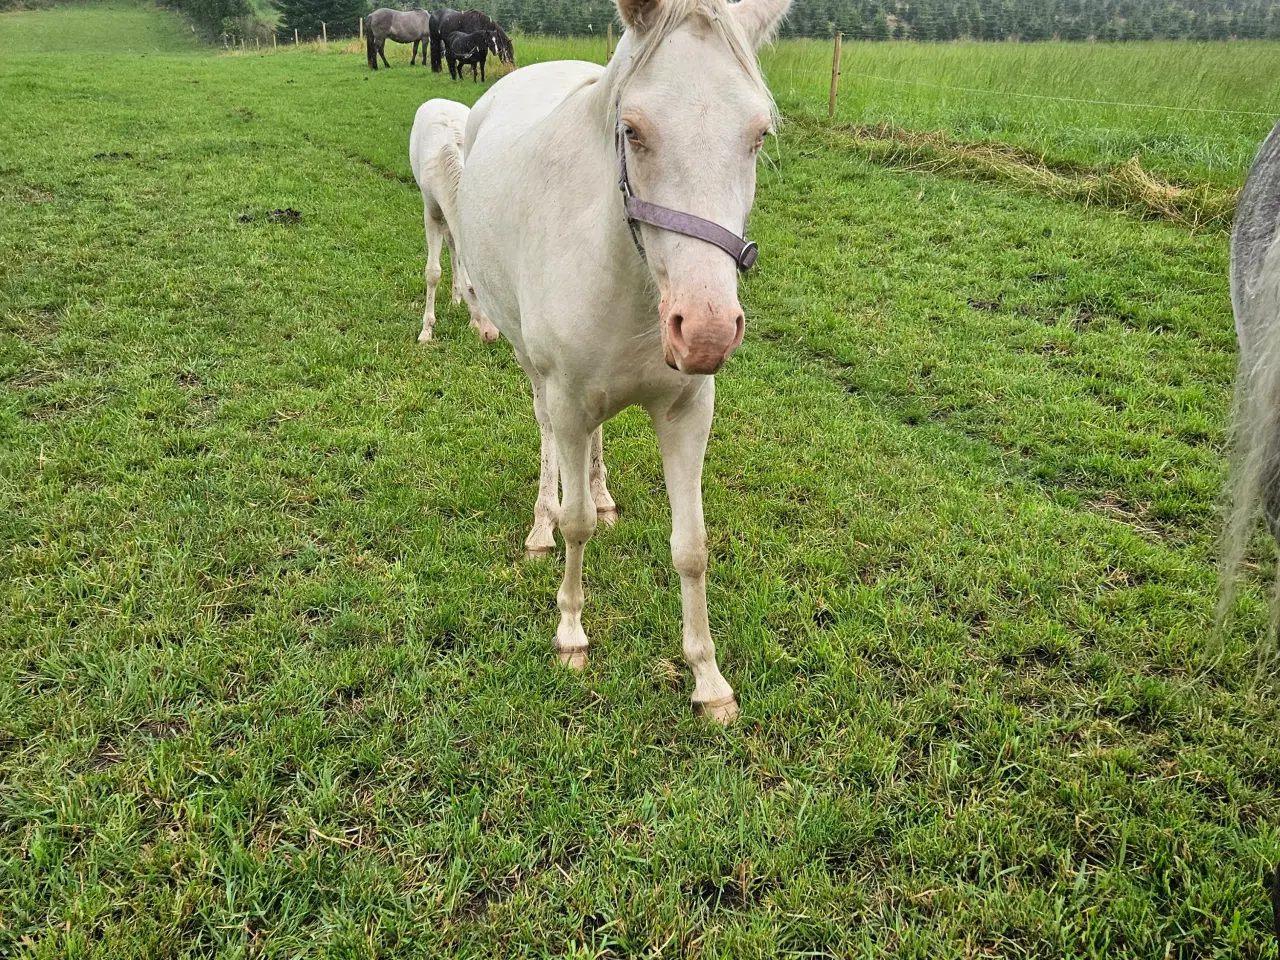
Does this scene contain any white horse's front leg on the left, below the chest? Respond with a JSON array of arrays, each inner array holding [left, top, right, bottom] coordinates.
[[547, 383, 595, 669]]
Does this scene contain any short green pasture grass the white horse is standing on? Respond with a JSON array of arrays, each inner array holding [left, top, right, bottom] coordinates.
[[0, 8, 1280, 960]]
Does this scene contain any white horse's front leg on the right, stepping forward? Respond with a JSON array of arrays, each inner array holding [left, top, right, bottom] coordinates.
[[650, 378, 737, 723]]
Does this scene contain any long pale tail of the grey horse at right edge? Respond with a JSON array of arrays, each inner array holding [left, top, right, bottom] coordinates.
[[1217, 236, 1280, 625]]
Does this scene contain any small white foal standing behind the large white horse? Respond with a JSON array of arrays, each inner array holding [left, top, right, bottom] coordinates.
[[408, 100, 498, 343]]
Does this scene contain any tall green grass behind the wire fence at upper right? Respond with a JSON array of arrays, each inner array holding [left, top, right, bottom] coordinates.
[[763, 41, 1280, 187]]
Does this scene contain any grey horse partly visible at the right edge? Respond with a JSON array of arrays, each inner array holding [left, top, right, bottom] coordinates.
[[1220, 123, 1280, 624]]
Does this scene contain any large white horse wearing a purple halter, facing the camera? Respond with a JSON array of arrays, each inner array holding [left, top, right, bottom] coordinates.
[[458, 0, 790, 722]]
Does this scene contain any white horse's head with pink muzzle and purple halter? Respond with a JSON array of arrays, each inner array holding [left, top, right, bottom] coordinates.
[[614, 0, 791, 374]]
